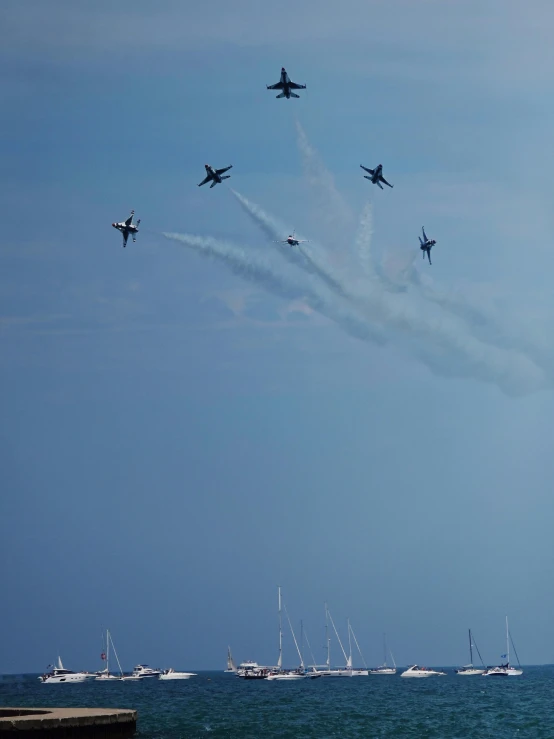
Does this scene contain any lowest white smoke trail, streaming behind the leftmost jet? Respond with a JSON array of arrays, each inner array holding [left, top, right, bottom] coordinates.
[[163, 233, 385, 344]]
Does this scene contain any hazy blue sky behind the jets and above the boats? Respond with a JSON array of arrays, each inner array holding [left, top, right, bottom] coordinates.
[[0, 0, 554, 672]]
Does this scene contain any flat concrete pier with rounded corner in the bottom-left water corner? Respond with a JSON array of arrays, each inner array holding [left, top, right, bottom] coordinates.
[[0, 708, 137, 739]]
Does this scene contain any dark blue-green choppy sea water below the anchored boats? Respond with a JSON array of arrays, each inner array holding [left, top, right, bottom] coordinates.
[[0, 667, 554, 739]]
